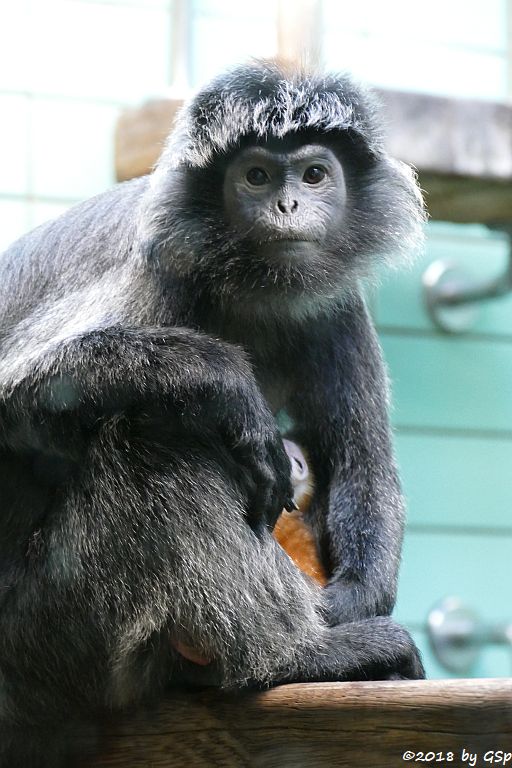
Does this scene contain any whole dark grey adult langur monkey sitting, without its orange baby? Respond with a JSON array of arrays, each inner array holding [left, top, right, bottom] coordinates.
[[0, 63, 423, 768]]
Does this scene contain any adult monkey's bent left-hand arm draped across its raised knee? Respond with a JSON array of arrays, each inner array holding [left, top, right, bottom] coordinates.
[[0, 326, 291, 527]]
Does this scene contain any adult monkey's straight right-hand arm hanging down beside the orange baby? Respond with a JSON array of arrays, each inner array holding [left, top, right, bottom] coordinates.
[[290, 300, 404, 622]]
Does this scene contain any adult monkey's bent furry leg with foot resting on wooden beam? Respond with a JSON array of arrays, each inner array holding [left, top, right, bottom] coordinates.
[[0, 416, 421, 768]]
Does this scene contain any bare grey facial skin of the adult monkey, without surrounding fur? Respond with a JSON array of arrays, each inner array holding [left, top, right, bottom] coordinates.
[[223, 144, 347, 263]]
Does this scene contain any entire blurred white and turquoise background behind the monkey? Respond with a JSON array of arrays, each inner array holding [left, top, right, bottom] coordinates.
[[0, 0, 512, 677]]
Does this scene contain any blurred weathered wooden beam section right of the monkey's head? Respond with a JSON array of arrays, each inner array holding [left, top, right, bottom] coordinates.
[[379, 90, 512, 224]]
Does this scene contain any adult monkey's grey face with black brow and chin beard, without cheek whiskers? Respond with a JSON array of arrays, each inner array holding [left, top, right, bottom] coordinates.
[[209, 136, 364, 311]]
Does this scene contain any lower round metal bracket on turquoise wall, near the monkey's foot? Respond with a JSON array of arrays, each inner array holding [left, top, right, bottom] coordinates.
[[427, 597, 512, 674]]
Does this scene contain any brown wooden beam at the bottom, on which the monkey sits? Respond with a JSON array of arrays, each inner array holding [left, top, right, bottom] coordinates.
[[91, 679, 512, 768]]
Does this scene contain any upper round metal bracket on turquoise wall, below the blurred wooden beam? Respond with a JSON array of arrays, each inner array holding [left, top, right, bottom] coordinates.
[[423, 228, 512, 333]]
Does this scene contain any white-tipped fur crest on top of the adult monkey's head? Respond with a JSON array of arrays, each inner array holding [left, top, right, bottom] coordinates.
[[161, 61, 383, 169]]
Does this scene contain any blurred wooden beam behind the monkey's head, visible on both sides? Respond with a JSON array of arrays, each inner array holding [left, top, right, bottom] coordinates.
[[116, 91, 512, 224]]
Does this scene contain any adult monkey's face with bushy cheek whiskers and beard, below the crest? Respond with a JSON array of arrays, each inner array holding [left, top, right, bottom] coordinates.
[[162, 129, 423, 317]]
